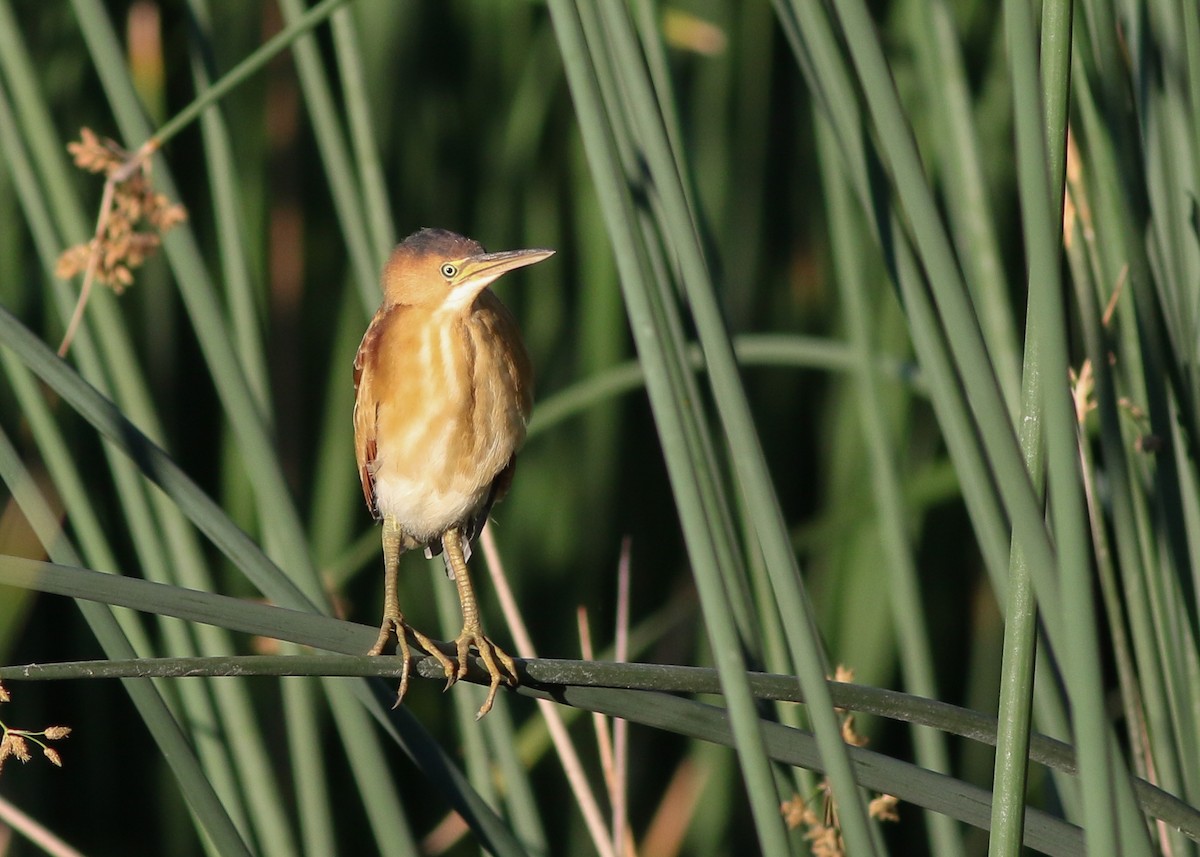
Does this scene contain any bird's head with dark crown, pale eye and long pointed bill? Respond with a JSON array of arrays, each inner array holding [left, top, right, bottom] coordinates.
[[383, 229, 554, 311]]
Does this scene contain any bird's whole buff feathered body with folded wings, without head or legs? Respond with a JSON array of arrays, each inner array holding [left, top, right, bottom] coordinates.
[[354, 285, 533, 552]]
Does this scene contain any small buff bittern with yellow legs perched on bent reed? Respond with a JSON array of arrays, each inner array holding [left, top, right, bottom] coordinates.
[[354, 228, 554, 720]]
